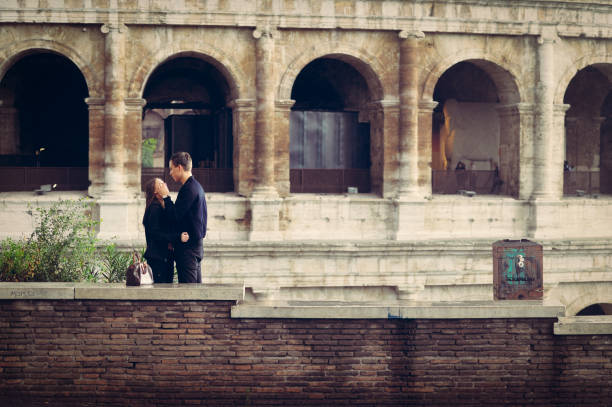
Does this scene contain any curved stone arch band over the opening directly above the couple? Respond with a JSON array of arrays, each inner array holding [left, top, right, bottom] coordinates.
[[128, 47, 248, 102]]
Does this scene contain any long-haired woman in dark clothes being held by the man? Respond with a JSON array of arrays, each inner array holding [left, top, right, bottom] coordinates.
[[142, 178, 178, 283]]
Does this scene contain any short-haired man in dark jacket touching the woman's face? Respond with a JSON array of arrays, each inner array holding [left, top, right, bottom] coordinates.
[[170, 152, 207, 283]]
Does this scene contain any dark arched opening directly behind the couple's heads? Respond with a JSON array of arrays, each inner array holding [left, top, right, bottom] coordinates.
[[142, 57, 234, 192]]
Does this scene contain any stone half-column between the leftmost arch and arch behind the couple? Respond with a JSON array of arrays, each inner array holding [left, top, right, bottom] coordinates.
[[102, 24, 127, 197]]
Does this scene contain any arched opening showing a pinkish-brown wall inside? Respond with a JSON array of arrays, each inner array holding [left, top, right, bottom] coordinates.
[[432, 60, 518, 199]]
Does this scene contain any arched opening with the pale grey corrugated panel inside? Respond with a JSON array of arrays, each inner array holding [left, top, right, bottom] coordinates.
[[289, 58, 372, 193]]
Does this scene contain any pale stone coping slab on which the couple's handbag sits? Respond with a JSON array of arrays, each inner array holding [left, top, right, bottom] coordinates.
[[0, 283, 244, 301]]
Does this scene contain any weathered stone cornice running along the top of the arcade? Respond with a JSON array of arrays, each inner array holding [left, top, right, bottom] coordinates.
[[0, 0, 612, 38]]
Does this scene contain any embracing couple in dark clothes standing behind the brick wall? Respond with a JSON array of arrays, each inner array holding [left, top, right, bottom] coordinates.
[[142, 152, 207, 283]]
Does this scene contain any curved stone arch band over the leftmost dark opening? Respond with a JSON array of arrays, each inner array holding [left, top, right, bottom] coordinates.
[[0, 39, 99, 98]]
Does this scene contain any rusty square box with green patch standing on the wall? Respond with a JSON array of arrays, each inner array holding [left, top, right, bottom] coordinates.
[[493, 239, 544, 300]]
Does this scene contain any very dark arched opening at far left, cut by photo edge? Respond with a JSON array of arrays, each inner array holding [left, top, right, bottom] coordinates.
[[0, 51, 89, 191]]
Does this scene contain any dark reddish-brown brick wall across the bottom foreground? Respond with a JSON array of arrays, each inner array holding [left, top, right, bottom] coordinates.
[[0, 300, 612, 406]]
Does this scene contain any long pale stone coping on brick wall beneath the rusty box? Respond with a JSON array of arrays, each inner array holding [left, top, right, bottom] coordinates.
[[231, 301, 565, 319]]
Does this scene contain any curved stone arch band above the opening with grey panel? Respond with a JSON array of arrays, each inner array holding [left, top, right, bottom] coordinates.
[[277, 44, 388, 102]]
